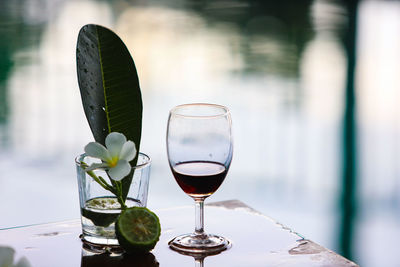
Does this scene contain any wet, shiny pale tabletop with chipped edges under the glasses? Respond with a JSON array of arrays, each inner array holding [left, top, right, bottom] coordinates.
[[0, 200, 357, 267]]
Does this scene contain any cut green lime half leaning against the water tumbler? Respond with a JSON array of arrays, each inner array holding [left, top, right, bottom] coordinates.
[[115, 207, 161, 253]]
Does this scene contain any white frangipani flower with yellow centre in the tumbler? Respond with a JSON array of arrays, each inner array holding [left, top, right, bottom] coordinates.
[[85, 132, 136, 181]]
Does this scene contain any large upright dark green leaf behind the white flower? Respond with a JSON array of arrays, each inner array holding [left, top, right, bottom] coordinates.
[[76, 24, 143, 199]]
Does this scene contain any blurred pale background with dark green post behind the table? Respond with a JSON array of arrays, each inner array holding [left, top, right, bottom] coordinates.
[[0, 0, 400, 267]]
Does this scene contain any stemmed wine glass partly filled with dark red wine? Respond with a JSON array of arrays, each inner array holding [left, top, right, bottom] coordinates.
[[167, 104, 233, 254]]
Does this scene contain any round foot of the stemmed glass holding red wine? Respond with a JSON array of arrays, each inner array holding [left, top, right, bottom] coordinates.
[[168, 234, 232, 255]]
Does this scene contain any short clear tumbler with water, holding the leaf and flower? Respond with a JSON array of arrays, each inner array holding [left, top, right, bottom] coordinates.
[[75, 153, 151, 247]]
